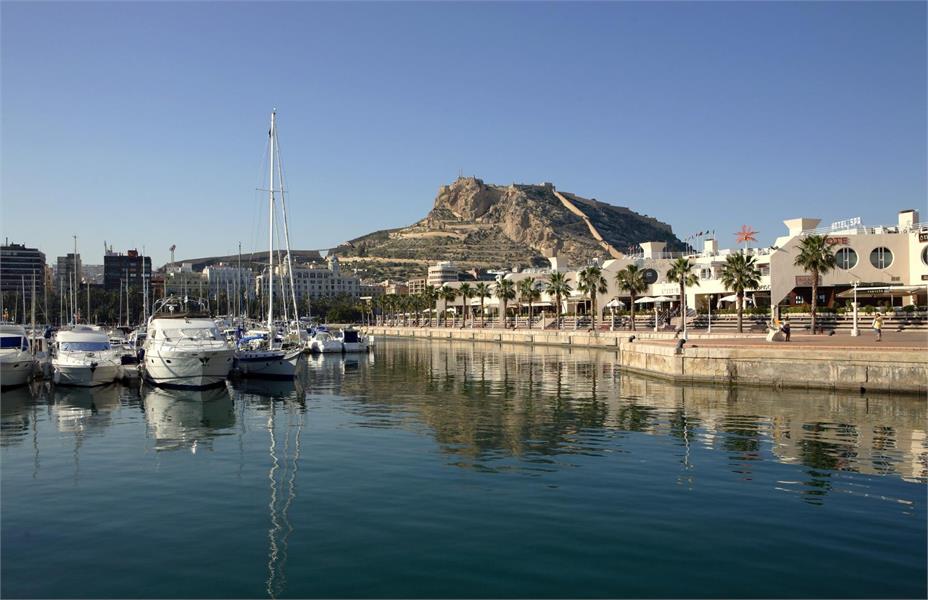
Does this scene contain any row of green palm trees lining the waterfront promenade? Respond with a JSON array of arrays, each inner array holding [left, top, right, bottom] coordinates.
[[373, 235, 835, 333]]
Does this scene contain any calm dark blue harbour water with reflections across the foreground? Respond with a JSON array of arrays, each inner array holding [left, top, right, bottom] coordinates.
[[0, 340, 928, 598]]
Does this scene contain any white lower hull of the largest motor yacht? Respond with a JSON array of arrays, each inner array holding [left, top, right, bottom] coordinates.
[[145, 349, 232, 389]]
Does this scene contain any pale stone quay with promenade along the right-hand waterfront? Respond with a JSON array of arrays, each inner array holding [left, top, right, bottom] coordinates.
[[365, 326, 928, 396]]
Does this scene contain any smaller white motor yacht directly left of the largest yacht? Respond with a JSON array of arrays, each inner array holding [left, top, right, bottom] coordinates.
[[52, 325, 121, 387]]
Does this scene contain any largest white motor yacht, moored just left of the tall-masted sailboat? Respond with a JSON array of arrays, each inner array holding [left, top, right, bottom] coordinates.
[[142, 296, 233, 388]]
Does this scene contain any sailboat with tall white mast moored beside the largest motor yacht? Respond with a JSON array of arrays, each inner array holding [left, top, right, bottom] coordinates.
[[236, 109, 302, 379]]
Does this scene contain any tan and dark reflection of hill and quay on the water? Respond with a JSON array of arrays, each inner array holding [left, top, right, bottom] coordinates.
[[342, 340, 928, 490]]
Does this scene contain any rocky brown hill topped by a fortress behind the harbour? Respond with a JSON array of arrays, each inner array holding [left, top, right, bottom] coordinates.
[[332, 177, 682, 278]]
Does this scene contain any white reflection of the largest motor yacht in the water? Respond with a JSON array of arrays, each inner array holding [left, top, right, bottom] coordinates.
[[142, 386, 235, 454]]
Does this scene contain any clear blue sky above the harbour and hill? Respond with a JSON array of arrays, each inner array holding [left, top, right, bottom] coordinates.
[[0, 1, 928, 264]]
